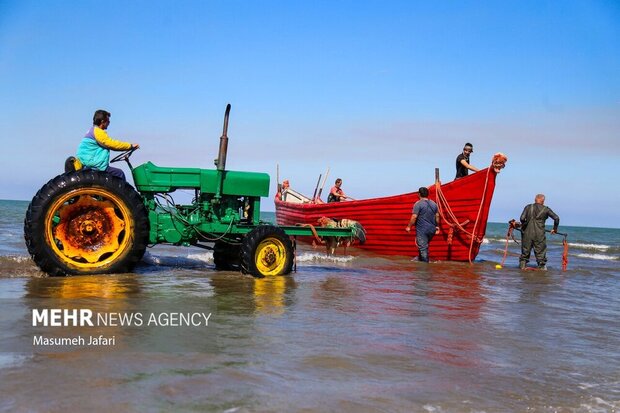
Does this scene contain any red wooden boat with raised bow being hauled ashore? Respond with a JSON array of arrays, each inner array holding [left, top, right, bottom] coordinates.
[[275, 153, 507, 261]]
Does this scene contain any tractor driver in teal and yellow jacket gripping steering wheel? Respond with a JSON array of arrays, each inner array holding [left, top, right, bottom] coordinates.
[[76, 109, 140, 180]]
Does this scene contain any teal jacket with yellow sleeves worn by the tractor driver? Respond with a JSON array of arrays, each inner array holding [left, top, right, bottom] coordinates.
[[76, 126, 131, 171]]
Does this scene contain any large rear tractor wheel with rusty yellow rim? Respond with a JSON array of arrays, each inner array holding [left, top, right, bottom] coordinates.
[[24, 170, 149, 275]]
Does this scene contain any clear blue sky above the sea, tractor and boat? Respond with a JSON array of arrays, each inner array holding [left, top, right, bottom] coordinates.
[[0, 0, 620, 227]]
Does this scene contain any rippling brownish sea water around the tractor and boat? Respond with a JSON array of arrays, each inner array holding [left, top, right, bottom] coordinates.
[[0, 201, 620, 412]]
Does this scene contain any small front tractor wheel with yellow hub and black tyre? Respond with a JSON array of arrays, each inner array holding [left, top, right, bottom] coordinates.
[[241, 225, 293, 277]]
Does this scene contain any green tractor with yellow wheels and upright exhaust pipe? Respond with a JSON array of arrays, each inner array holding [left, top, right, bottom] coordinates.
[[24, 105, 364, 277]]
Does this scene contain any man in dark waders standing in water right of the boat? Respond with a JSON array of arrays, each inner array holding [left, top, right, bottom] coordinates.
[[519, 194, 560, 270]]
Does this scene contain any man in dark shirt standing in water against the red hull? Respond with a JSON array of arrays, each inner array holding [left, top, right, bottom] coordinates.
[[405, 187, 439, 262]]
